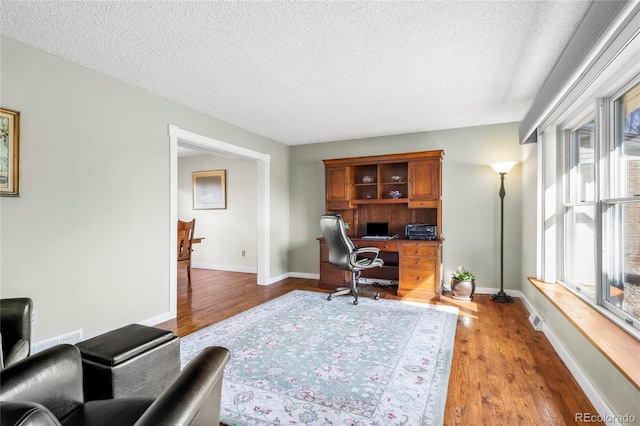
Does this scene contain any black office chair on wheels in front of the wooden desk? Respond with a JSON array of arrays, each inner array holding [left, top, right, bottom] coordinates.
[[320, 214, 384, 305]]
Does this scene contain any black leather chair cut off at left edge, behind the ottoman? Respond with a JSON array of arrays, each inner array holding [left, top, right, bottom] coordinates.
[[0, 297, 33, 368]]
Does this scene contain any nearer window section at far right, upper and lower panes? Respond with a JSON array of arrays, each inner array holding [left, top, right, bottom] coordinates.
[[603, 83, 640, 321]]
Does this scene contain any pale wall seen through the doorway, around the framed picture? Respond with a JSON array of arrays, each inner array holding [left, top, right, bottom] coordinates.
[[178, 155, 258, 273]]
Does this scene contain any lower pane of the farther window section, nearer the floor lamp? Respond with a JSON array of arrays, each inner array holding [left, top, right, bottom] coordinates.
[[564, 205, 595, 298]]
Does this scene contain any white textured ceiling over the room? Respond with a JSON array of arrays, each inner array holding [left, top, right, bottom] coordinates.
[[0, 0, 590, 145]]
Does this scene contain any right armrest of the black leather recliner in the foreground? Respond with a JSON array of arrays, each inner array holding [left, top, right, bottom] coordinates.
[[135, 346, 231, 426]]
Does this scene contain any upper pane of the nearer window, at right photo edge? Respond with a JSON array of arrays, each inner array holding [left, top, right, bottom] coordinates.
[[611, 84, 640, 198]]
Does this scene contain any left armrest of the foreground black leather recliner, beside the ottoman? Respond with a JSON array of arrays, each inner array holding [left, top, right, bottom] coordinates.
[[0, 344, 84, 419]]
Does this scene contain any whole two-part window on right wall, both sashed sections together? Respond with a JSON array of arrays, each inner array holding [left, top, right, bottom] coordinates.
[[559, 80, 640, 328]]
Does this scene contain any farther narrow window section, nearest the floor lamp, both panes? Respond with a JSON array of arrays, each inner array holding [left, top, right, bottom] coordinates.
[[563, 118, 596, 299]]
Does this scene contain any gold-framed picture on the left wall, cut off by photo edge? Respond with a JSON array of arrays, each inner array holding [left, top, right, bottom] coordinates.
[[0, 108, 20, 197]]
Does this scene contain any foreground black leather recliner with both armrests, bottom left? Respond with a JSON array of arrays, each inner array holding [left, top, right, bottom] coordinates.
[[0, 345, 230, 426]]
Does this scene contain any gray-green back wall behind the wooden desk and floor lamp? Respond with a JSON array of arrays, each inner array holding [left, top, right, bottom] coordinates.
[[289, 123, 523, 290]]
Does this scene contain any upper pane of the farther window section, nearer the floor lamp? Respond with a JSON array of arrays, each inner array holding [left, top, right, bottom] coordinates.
[[568, 120, 596, 203]]
